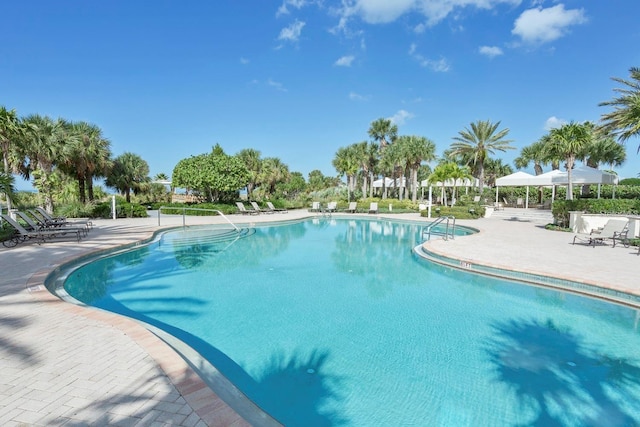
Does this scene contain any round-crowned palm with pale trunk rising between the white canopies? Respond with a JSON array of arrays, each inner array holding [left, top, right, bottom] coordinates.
[[549, 122, 592, 200]]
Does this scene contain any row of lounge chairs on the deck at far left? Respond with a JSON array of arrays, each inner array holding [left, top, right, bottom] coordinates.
[[2, 207, 93, 247]]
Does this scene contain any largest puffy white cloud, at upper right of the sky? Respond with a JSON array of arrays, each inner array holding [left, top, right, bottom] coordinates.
[[511, 4, 587, 44]]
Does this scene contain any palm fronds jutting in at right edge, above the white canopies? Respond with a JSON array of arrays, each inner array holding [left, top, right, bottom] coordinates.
[[599, 67, 640, 152]]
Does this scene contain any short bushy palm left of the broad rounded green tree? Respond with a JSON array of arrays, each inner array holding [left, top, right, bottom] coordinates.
[[105, 152, 150, 203]]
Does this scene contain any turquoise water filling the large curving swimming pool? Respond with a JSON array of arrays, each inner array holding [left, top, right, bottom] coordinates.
[[65, 219, 640, 426]]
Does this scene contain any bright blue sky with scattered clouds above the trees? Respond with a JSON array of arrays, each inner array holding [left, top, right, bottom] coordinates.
[[0, 0, 640, 188]]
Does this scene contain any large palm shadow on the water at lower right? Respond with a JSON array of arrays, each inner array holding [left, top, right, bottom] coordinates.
[[485, 320, 640, 427]]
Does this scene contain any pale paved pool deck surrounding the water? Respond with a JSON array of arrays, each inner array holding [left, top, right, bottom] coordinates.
[[0, 209, 640, 427]]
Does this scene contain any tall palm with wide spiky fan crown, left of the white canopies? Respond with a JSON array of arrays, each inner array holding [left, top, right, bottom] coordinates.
[[451, 120, 514, 193]]
